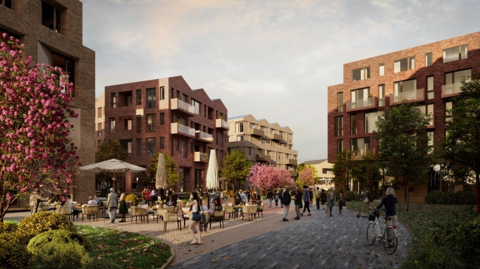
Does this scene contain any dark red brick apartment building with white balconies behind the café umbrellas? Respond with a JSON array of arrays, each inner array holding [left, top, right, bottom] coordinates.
[[95, 76, 229, 191]]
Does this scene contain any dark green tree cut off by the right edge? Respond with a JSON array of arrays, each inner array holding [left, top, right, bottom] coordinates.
[[442, 74, 480, 213]]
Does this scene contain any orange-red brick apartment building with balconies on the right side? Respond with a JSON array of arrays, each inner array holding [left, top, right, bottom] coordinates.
[[328, 32, 480, 201]]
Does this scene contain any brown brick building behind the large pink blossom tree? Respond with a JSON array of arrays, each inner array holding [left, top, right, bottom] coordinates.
[[0, 0, 95, 207]]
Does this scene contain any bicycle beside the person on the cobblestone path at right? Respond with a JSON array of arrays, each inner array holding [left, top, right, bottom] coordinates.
[[367, 208, 398, 255]]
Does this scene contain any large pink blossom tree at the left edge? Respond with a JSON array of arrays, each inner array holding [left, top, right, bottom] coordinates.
[[0, 34, 80, 222]]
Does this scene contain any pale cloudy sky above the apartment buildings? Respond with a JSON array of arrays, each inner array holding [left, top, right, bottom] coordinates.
[[81, 0, 480, 163]]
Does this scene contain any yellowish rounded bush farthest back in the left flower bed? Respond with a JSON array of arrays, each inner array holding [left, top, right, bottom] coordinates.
[[18, 211, 77, 238]]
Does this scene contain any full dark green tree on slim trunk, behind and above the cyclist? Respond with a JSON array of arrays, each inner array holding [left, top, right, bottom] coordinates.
[[374, 103, 433, 211]]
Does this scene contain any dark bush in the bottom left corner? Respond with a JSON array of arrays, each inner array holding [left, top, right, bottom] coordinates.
[[0, 232, 30, 268]]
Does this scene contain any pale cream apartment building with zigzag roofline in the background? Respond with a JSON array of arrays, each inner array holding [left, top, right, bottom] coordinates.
[[228, 115, 298, 176]]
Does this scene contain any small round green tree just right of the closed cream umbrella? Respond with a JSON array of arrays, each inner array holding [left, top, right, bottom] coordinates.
[[220, 150, 252, 190]]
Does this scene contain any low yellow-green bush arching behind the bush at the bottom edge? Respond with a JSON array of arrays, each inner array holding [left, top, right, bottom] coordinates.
[[27, 227, 92, 252]]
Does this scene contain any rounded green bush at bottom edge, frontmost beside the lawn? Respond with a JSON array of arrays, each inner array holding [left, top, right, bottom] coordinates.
[[31, 241, 90, 269]]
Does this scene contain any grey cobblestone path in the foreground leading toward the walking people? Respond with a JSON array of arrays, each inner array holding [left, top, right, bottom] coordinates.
[[172, 204, 410, 269]]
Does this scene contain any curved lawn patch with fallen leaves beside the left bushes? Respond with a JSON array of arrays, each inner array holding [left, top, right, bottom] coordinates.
[[78, 225, 172, 268]]
